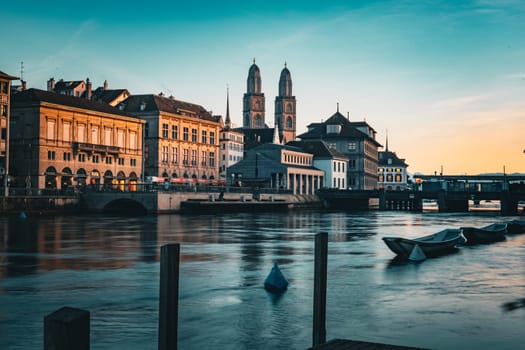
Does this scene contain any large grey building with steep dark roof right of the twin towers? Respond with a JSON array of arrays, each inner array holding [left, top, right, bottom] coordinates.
[[298, 110, 381, 190]]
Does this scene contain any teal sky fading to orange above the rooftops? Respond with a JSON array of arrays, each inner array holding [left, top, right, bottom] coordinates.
[[0, 0, 525, 175]]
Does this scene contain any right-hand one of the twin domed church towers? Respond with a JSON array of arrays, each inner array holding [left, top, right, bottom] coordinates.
[[275, 63, 296, 144]]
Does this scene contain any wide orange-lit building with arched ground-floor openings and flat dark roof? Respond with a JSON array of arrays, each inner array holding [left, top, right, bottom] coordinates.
[[10, 89, 144, 191]]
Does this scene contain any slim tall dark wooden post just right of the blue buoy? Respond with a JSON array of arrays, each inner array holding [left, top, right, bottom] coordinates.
[[312, 232, 328, 346]]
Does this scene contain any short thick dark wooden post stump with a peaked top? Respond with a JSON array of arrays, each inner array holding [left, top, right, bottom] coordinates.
[[44, 306, 90, 350]]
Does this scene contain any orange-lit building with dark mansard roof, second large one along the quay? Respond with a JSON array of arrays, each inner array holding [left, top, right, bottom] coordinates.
[[117, 94, 221, 183]]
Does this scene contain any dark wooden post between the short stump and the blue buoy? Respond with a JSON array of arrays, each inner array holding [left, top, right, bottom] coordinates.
[[159, 243, 180, 350]]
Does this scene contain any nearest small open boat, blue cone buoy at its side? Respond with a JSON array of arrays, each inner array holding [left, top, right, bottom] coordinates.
[[383, 228, 467, 261]]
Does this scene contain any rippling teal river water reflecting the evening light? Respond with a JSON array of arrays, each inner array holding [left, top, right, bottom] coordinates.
[[0, 211, 525, 349]]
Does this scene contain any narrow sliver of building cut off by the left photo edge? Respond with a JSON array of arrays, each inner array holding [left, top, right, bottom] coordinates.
[[0, 71, 18, 194]]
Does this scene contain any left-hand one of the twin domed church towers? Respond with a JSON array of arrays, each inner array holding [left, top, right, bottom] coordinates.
[[242, 59, 266, 129]]
